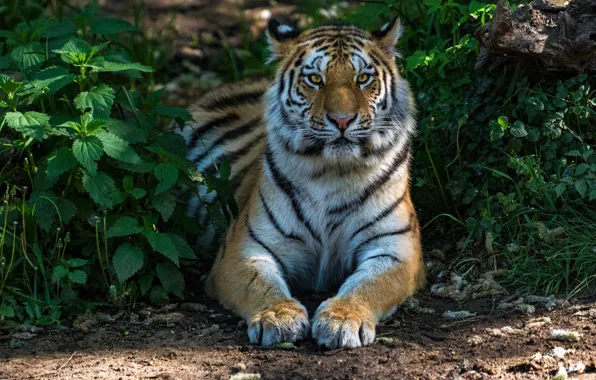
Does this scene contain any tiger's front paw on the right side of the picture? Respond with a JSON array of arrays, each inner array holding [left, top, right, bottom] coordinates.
[[312, 298, 375, 349]]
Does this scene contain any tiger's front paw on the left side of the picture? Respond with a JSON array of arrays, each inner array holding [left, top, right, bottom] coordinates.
[[248, 300, 310, 346]]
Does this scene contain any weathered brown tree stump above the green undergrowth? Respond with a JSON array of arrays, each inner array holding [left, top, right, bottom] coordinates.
[[476, 0, 596, 74]]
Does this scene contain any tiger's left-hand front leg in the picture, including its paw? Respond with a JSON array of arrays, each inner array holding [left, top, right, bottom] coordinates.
[[205, 212, 310, 346]]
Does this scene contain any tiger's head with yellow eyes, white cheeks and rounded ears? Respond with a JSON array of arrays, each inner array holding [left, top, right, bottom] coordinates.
[[267, 18, 414, 161]]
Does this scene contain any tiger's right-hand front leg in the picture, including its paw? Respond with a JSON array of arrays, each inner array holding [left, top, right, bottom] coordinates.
[[312, 217, 425, 348]]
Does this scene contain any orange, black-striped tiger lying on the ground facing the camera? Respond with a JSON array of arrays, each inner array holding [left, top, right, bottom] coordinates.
[[180, 17, 425, 349]]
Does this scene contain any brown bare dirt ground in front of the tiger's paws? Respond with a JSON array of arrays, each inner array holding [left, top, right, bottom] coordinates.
[[0, 292, 596, 379]]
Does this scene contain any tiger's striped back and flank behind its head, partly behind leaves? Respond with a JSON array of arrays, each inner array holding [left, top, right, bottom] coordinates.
[[180, 79, 271, 239]]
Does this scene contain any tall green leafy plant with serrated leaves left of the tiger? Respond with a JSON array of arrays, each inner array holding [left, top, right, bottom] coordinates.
[[0, 4, 202, 323]]
